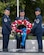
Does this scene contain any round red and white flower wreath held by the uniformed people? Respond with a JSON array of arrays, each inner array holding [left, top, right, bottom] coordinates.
[[11, 19, 32, 34]]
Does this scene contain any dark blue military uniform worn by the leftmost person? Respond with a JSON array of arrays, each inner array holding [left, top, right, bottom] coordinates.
[[2, 8, 11, 51]]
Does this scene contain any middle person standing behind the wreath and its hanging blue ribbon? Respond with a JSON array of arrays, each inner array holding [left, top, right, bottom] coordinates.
[[16, 9, 29, 49]]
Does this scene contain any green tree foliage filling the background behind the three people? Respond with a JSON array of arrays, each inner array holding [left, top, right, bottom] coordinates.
[[0, 0, 44, 25]]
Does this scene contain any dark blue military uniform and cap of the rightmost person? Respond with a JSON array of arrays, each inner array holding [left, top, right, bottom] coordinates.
[[32, 8, 42, 51]]
